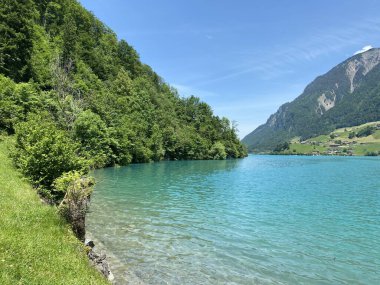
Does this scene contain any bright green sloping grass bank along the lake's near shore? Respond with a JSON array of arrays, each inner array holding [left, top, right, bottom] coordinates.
[[0, 136, 109, 285]]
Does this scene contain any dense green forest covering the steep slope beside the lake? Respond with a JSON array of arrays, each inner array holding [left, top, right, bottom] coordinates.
[[0, 0, 246, 199]]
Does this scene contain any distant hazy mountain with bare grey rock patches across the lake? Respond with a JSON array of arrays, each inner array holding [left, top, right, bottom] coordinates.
[[242, 48, 380, 152]]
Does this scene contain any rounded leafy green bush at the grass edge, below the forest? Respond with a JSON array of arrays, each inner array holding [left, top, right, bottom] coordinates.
[[14, 113, 86, 198]]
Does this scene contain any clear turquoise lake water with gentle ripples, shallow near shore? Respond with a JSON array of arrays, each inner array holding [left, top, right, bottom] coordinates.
[[87, 156, 380, 285]]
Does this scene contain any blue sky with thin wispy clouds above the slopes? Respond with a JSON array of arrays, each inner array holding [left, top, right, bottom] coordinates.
[[80, 0, 380, 138]]
